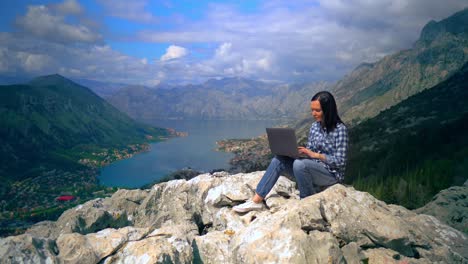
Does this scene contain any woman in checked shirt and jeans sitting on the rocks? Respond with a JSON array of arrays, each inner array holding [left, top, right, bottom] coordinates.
[[233, 91, 348, 213]]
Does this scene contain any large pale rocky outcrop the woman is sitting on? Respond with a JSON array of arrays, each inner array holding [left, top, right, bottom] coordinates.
[[0, 172, 468, 263]]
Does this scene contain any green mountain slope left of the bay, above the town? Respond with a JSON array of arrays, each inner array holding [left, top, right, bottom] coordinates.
[[0, 75, 167, 180]]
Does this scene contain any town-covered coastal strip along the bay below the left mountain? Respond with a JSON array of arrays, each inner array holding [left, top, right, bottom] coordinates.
[[0, 129, 188, 237]]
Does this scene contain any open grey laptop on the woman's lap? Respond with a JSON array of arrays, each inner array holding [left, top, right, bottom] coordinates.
[[266, 127, 303, 158]]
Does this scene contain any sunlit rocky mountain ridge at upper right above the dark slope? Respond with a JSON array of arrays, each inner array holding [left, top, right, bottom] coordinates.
[[332, 6, 468, 124]]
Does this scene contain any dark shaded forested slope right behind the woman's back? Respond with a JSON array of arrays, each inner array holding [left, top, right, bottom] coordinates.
[[346, 63, 468, 208]]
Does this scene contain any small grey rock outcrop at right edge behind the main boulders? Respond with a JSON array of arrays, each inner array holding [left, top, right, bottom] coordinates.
[[415, 181, 468, 234]]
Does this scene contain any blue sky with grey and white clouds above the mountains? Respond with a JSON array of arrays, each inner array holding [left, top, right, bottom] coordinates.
[[0, 0, 468, 85]]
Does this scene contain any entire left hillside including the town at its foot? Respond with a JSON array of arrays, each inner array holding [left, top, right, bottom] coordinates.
[[0, 75, 169, 234]]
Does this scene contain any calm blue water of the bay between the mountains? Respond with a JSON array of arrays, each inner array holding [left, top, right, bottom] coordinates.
[[98, 120, 277, 188]]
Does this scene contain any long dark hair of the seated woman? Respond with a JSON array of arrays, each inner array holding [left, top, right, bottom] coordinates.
[[310, 91, 343, 133]]
